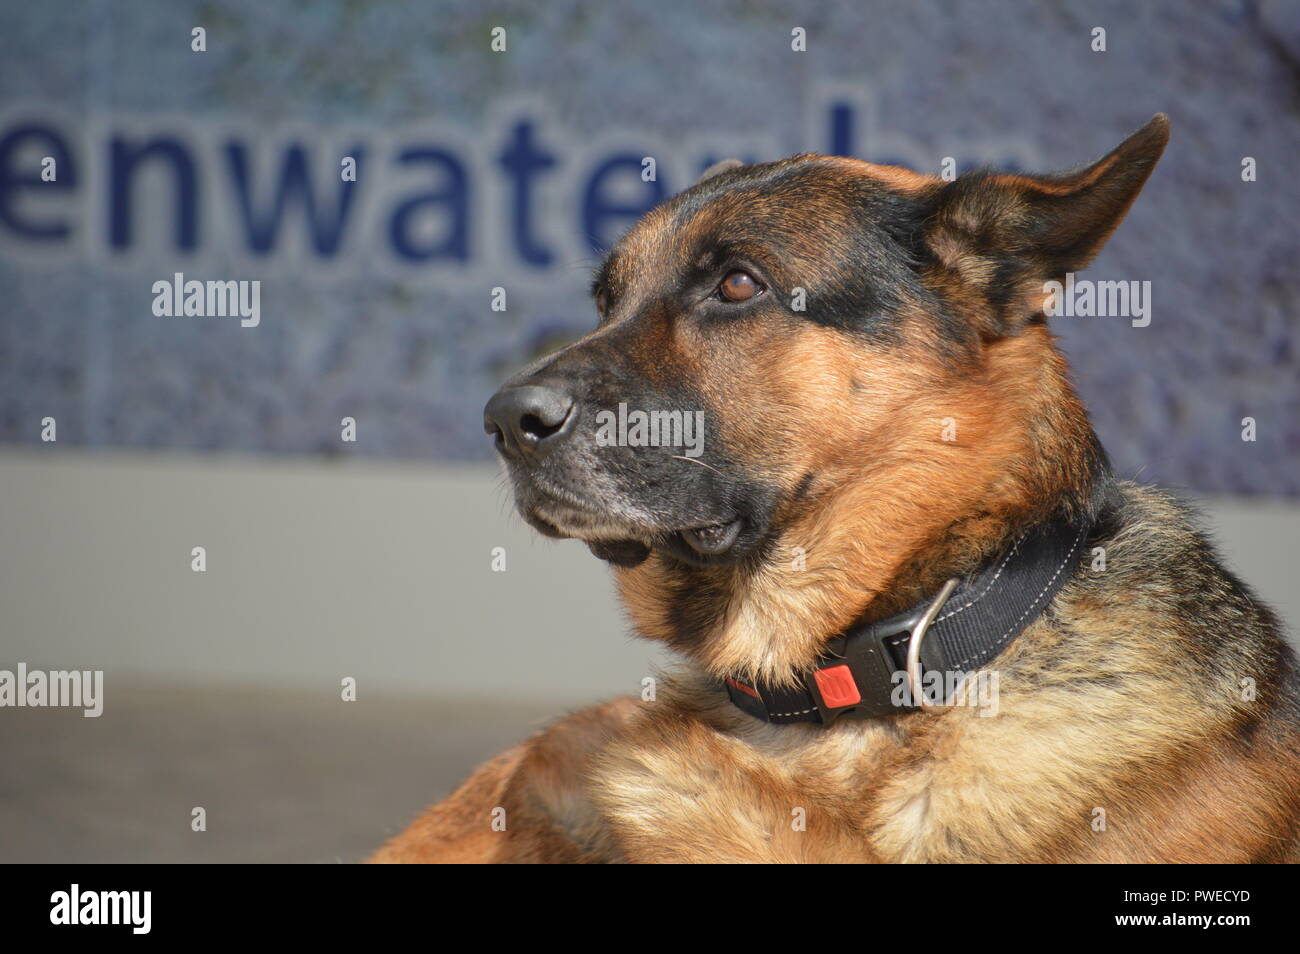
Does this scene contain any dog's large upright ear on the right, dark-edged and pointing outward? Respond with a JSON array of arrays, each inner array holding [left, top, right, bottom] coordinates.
[[926, 113, 1169, 335]]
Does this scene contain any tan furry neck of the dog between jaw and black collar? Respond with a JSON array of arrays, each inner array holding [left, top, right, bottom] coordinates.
[[616, 328, 1106, 684]]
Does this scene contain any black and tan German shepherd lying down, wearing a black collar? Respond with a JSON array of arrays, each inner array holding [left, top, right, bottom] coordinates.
[[372, 116, 1300, 862]]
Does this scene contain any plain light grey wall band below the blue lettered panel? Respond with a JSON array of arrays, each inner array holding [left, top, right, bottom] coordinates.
[[0, 450, 1300, 702]]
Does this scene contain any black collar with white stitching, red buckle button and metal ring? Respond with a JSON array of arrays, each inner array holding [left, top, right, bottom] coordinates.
[[725, 517, 1089, 725]]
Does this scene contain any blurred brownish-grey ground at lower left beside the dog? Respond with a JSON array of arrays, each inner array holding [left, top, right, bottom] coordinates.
[[0, 688, 563, 863]]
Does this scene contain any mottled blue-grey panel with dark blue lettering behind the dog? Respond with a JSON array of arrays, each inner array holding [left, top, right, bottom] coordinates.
[[0, 0, 1300, 495]]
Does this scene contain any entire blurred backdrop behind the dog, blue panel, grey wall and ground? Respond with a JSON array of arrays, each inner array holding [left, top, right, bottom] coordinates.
[[0, 0, 1300, 862]]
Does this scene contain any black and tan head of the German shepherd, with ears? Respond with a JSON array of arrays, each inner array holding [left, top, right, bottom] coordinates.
[[485, 116, 1167, 600]]
